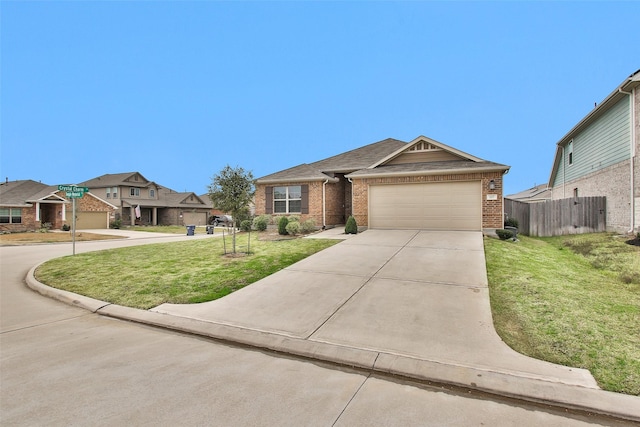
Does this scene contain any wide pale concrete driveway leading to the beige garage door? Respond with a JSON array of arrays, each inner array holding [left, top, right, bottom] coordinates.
[[152, 230, 597, 388]]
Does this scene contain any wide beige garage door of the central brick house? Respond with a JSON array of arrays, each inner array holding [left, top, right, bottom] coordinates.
[[369, 181, 482, 230]]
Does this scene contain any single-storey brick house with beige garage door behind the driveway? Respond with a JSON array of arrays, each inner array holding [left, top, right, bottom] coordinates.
[[255, 136, 509, 230]]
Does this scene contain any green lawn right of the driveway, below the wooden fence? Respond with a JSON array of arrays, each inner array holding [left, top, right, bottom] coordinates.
[[485, 233, 640, 395]]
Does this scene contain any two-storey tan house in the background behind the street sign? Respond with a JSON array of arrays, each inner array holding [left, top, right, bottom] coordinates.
[[79, 172, 212, 229]]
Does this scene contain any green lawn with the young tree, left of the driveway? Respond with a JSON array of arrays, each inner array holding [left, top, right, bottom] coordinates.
[[36, 233, 338, 309]]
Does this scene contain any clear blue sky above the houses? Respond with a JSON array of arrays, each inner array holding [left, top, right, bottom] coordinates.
[[0, 1, 640, 194]]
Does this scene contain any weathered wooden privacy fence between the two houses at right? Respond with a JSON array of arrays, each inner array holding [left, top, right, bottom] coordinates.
[[504, 197, 607, 237]]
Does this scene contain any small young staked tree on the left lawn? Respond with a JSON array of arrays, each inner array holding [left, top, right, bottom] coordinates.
[[208, 165, 255, 253]]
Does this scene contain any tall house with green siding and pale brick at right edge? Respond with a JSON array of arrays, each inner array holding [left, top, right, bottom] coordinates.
[[549, 70, 640, 232]]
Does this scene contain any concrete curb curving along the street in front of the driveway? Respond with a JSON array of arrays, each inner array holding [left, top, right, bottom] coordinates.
[[26, 270, 640, 422]]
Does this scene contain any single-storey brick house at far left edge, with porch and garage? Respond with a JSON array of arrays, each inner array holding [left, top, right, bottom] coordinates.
[[0, 180, 117, 232]]
